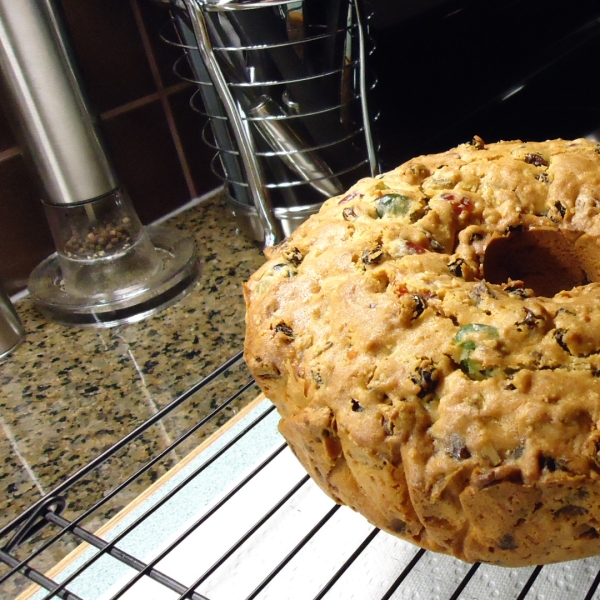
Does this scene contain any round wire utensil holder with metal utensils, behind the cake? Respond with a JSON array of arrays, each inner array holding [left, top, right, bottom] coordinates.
[[163, 0, 379, 246]]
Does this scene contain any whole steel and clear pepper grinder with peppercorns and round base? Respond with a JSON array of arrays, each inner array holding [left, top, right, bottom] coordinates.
[[0, 0, 199, 327]]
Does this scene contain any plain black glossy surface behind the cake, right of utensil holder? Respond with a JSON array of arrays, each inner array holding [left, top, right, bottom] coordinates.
[[370, 0, 600, 168]]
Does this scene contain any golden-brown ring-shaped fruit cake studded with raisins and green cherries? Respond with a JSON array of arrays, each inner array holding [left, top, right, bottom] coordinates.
[[244, 137, 600, 566]]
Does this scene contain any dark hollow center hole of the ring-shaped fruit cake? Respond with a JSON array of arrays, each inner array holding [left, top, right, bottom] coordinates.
[[483, 229, 600, 298]]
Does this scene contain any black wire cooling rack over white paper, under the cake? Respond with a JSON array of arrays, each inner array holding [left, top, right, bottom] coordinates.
[[0, 346, 600, 600]]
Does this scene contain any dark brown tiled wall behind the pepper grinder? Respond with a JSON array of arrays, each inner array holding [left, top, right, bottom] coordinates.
[[0, 0, 219, 294]]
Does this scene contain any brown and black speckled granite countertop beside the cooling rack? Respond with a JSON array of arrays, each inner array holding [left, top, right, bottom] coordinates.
[[0, 194, 264, 576]]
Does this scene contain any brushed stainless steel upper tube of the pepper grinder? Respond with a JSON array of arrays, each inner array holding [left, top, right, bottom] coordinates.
[[0, 0, 117, 204]]
